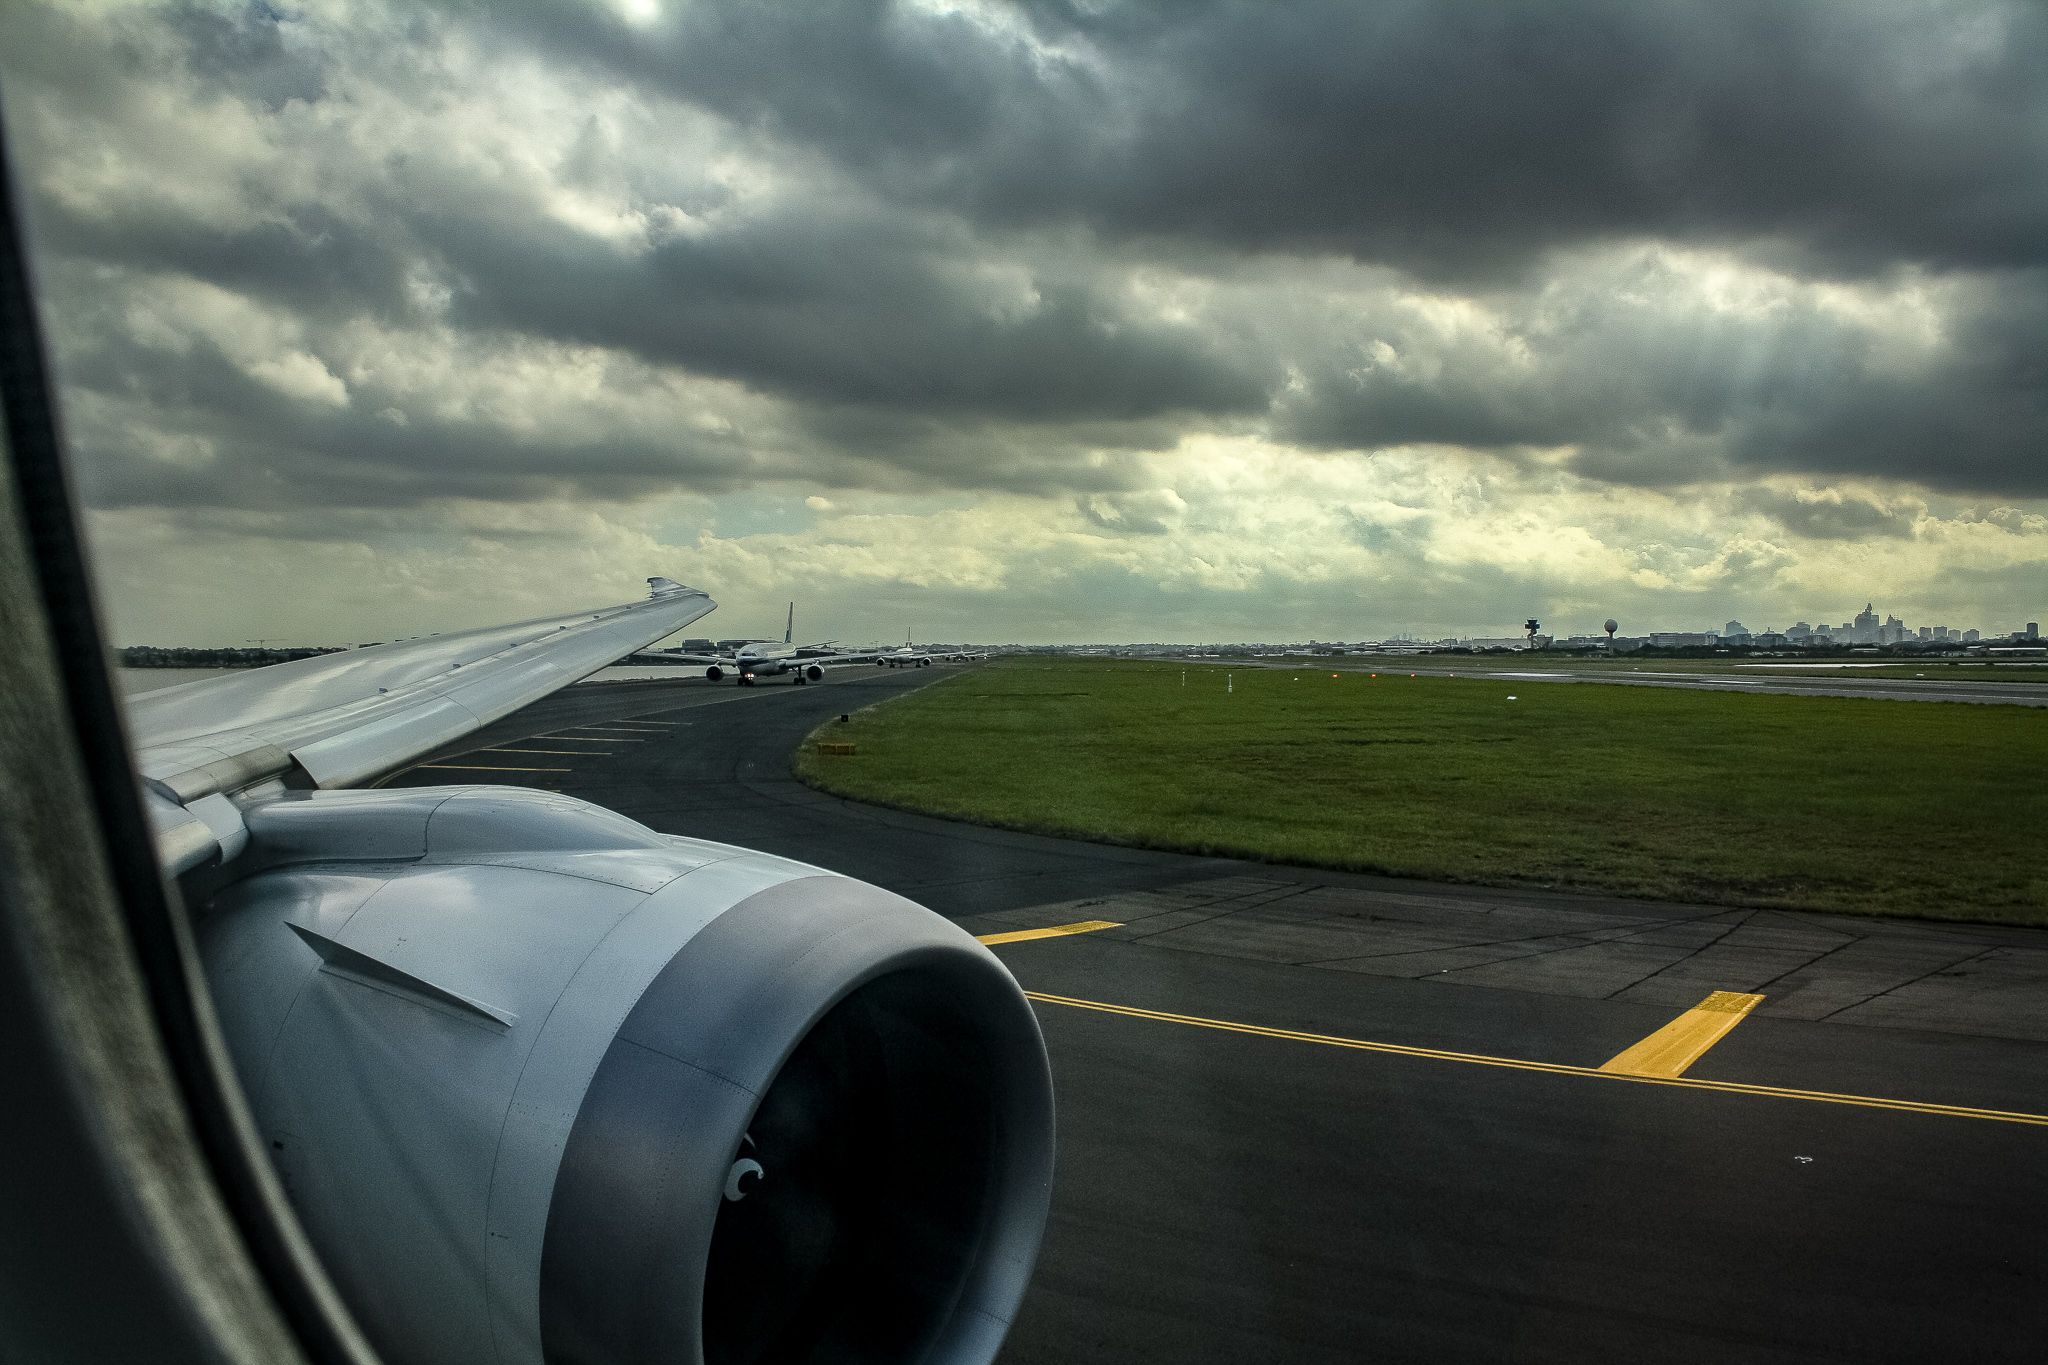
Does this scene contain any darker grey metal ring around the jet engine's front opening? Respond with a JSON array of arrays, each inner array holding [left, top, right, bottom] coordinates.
[[539, 876, 1053, 1365]]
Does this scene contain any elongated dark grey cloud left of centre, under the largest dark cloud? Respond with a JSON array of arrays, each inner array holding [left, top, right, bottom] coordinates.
[[414, 192, 1266, 422]]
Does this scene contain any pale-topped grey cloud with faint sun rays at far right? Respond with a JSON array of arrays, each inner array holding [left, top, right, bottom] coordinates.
[[1276, 255, 2048, 497]]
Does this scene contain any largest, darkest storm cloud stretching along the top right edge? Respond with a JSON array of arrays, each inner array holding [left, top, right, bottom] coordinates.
[[522, 0, 2048, 278]]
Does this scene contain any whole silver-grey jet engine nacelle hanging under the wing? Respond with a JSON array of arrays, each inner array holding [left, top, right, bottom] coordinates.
[[199, 788, 1053, 1365]]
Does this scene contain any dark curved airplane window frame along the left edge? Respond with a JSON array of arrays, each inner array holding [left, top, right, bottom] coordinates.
[[0, 112, 377, 1365]]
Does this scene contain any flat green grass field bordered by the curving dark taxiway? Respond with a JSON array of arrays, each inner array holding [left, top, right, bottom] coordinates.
[[795, 659, 2048, 923]]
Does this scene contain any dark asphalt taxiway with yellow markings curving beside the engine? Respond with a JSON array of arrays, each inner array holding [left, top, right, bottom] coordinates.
[[395, 669, 2048, 1363]]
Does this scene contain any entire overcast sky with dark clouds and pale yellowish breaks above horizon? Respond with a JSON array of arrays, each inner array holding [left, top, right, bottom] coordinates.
[[0, 0, 2048, 643]]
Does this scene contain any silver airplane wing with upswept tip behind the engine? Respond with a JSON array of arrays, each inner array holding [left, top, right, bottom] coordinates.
[[129, 577, 717, 874]]
